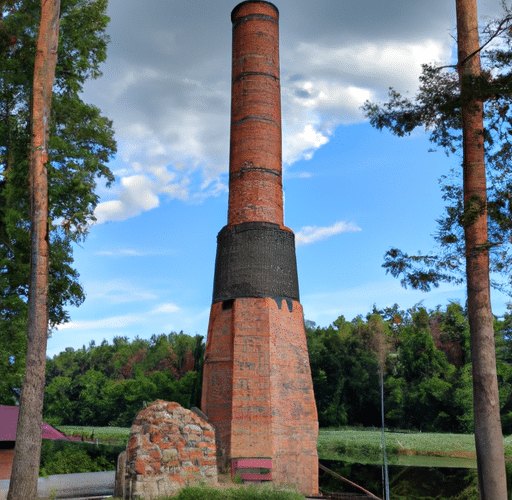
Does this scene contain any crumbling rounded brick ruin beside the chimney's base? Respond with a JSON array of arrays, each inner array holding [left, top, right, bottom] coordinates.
[[121, 400, 217, 500]]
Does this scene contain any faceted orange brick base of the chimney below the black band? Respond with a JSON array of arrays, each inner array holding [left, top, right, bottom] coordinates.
[[201, 298, 318, 494]]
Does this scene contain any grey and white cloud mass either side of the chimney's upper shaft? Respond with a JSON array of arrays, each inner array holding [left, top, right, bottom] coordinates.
[[81, 0, 460, 224]]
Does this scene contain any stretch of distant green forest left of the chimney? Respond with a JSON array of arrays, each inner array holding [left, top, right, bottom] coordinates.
[[43, 332, 204, 427]]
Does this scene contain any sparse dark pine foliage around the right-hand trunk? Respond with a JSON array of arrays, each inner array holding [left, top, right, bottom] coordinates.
[[363, 11, 512, 293]]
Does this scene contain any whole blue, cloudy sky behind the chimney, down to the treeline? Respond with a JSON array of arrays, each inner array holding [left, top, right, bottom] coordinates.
[[48, 0, 507, 356]]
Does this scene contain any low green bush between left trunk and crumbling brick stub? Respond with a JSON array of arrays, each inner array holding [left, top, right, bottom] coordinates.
[[39, 439, 125, 477]]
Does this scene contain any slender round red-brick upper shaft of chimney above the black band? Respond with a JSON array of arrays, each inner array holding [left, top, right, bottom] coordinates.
[[228, 2, 283, 226]]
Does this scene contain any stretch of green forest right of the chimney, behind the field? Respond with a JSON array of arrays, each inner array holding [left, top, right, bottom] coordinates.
[[306, 303, 512, 434]]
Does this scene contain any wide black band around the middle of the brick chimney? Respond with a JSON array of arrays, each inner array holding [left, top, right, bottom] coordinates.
[[213, 222, 299, 303]]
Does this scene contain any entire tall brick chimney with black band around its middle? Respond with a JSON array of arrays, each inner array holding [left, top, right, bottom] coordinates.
[[202, 0, 318, 494]]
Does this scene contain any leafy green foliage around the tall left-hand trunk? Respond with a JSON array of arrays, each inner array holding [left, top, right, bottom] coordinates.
[[0, 0, 116, 404]]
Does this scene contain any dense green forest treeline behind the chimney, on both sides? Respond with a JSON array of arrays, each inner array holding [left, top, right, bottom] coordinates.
[[8, 303, 512, 434]]
